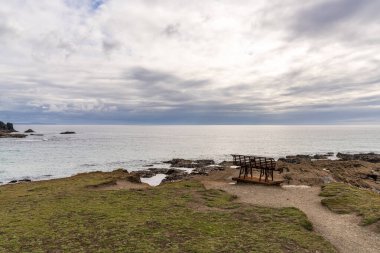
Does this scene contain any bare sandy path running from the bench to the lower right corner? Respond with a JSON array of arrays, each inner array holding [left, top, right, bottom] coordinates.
[[203, 181, 380, 253]]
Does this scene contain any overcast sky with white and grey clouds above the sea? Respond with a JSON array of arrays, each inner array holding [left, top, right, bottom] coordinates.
[[0, 0, 380, 124]]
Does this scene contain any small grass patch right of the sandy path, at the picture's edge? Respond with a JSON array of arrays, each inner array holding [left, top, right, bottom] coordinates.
[[320, 183, 380, 227]]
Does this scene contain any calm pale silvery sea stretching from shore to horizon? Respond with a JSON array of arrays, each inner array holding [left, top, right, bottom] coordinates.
[[0, 125, 380, 183]]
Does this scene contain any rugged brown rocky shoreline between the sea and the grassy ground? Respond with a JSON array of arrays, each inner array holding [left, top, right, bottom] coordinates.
[[8, 153, 380, 193]]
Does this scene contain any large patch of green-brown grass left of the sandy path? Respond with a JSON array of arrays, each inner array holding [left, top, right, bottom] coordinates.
[[0, 171, 335, 253]]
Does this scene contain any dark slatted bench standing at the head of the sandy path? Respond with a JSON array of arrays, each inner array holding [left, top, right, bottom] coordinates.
[[232, 155, 276, 182]]
